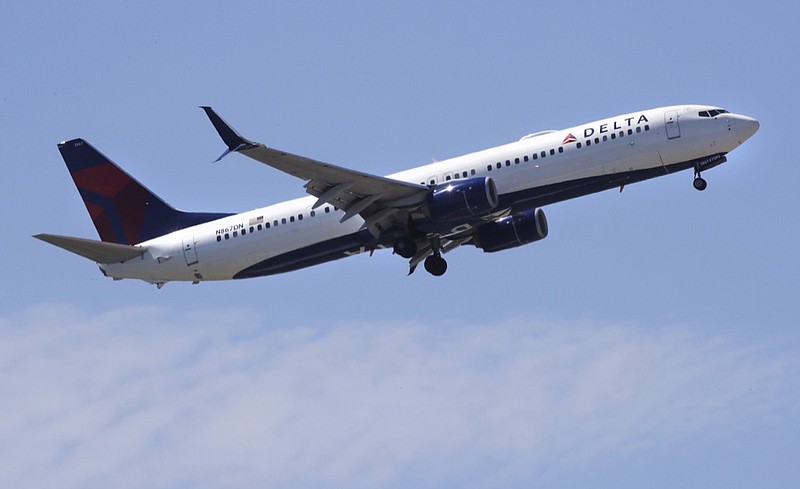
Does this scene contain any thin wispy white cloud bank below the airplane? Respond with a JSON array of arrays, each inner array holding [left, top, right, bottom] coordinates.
[[0, 307, 797, 488]]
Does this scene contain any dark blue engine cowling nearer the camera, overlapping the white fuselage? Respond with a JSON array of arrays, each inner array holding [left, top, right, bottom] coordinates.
[[425, 177, 498, 222]]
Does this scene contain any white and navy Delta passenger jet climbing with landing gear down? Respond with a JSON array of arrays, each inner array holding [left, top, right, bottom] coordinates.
[[34, 105, 759, 289]]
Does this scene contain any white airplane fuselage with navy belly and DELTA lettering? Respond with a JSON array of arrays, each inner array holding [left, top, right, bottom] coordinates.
[[47, 105, 758, 284]]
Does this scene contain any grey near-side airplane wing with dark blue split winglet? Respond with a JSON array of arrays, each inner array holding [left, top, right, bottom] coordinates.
[[201, 106, 430, 237]]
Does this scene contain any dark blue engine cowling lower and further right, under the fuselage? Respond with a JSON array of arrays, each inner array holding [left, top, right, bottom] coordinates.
[[474, 209, 547, 253]]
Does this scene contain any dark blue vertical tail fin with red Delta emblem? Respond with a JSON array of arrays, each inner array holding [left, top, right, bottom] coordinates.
[[58, 139, 230, 245]]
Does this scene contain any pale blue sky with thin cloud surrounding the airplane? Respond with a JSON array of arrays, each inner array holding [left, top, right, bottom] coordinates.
[[0, 2, 800, 488]]
